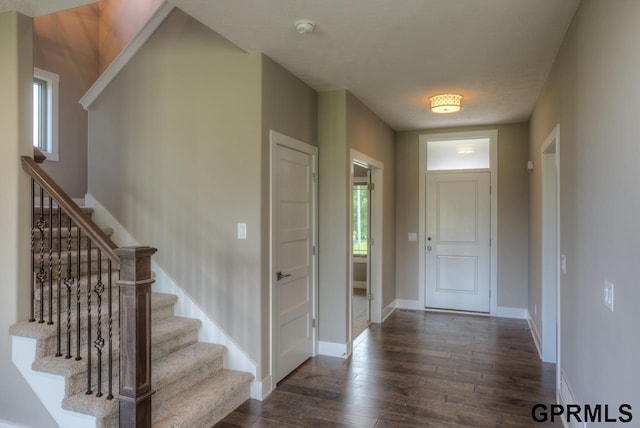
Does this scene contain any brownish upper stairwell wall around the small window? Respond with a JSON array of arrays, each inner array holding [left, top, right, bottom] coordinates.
[[33, 5, 98, 198]]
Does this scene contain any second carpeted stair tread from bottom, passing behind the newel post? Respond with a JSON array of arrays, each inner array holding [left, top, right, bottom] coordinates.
[[62, 343, 226, 418]]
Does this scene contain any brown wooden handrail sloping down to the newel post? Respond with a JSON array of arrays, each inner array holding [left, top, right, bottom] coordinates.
[[21, 156, 120, 266]]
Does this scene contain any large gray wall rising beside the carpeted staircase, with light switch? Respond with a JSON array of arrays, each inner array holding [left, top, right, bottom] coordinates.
[[89, 9, 264, 376]]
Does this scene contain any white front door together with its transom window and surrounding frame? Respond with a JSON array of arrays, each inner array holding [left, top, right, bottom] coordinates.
[[415, 130, 499, 315]]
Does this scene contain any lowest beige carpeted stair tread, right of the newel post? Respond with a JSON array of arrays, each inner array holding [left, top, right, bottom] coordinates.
[[153, 370, 253, 428]]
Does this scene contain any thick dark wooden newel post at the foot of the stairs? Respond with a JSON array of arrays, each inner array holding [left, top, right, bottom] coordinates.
[[115, 247, 157, 428]]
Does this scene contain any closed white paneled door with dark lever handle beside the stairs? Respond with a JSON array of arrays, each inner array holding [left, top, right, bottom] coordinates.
[[272, 137, 315, 382]]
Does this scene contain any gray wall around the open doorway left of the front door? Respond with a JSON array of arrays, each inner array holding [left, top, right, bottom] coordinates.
[[318, 89, 395, 343]]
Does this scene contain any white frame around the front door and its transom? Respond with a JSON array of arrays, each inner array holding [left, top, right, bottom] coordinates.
[[411, 129, 500, 316]]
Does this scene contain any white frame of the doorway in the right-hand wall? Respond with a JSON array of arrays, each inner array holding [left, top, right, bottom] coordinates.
[[540, 124, 562, 384]]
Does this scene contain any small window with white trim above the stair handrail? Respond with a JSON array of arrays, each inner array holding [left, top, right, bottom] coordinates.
[[33, 67, 60, 161]]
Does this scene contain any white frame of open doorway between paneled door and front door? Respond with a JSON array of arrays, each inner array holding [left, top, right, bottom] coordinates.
[[347, 149, 384, 348]]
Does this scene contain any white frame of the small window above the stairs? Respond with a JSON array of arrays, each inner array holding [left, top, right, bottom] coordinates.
[[33, 67, 60, 162]]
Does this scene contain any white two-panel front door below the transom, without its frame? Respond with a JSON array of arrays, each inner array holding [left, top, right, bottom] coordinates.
[[425, 172, 491, 312]]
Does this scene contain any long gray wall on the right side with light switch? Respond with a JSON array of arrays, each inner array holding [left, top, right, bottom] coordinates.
[[529, 0, 640, 408]]
